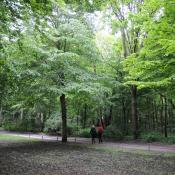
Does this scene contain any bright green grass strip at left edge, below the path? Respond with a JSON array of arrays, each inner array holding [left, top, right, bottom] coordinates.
[[0, 134, 39, 142]]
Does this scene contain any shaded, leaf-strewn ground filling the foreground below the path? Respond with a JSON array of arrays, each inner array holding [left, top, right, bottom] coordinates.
[[0, 133, 175, 175]]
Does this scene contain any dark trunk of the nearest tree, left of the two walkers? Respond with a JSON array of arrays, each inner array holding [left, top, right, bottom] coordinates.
[[60, 94, 67, 142]]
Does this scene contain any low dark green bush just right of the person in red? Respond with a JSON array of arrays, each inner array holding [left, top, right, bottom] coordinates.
[[103, 125, 123, 140]]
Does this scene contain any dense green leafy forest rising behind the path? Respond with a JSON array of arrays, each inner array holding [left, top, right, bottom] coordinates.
[[0, 0, 175, 143]]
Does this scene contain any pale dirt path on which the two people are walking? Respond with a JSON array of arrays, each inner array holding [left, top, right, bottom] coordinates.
[[0, 131, 175, 153]]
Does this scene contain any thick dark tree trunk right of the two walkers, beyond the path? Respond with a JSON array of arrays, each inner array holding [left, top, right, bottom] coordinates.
[[131, 85, 138, 139]]
